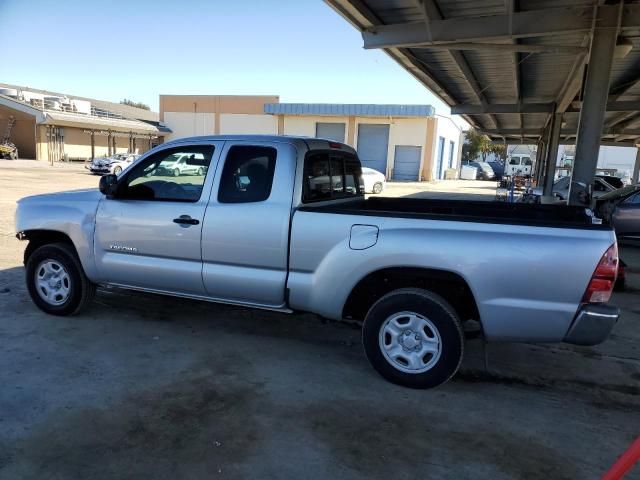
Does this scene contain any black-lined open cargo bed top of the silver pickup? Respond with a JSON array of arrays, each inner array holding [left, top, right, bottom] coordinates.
[[300, 197, 611, 230]]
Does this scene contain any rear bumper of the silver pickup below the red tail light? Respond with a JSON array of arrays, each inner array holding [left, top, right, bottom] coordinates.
[[564, 305, 620, 345]]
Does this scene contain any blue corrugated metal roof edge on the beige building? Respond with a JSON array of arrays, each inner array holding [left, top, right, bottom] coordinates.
[[264, 103, 435, 117]]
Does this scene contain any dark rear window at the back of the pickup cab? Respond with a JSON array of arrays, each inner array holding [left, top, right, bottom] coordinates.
[[302, 152, 364, 203]]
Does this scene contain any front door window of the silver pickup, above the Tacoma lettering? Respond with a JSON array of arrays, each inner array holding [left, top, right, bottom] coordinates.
[[116, 145, 214, 202]]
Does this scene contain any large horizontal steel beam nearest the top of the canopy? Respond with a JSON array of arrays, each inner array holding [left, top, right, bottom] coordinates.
[[362, 4, 640, 48]]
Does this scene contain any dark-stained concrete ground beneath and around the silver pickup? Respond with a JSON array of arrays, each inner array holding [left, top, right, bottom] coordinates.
[[0, 161, 640, 480]]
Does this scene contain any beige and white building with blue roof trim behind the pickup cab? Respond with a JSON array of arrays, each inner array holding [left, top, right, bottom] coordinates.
[[160, 95, 462, 181]]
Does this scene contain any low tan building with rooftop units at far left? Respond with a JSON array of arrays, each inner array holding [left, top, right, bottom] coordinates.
[[0, 85, 170, 161]]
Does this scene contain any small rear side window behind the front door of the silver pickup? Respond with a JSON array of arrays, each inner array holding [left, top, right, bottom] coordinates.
[[218, 145, 277, 203]]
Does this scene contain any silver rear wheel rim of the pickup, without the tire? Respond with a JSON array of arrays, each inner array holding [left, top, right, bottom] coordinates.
[[378, 312, 442, 374]]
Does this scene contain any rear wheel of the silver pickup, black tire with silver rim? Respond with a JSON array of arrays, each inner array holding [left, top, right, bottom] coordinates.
[[362, 288, 464, 388]]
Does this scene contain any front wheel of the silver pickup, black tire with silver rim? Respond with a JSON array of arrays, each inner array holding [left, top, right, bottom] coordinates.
[[26, 243, 96, 316]]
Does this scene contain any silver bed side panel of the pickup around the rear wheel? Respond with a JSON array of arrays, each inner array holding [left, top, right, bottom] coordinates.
[[288, 211, 615, 341]]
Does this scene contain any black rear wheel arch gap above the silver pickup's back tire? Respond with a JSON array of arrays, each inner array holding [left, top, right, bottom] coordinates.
[[342, 267, 481, 322]]
